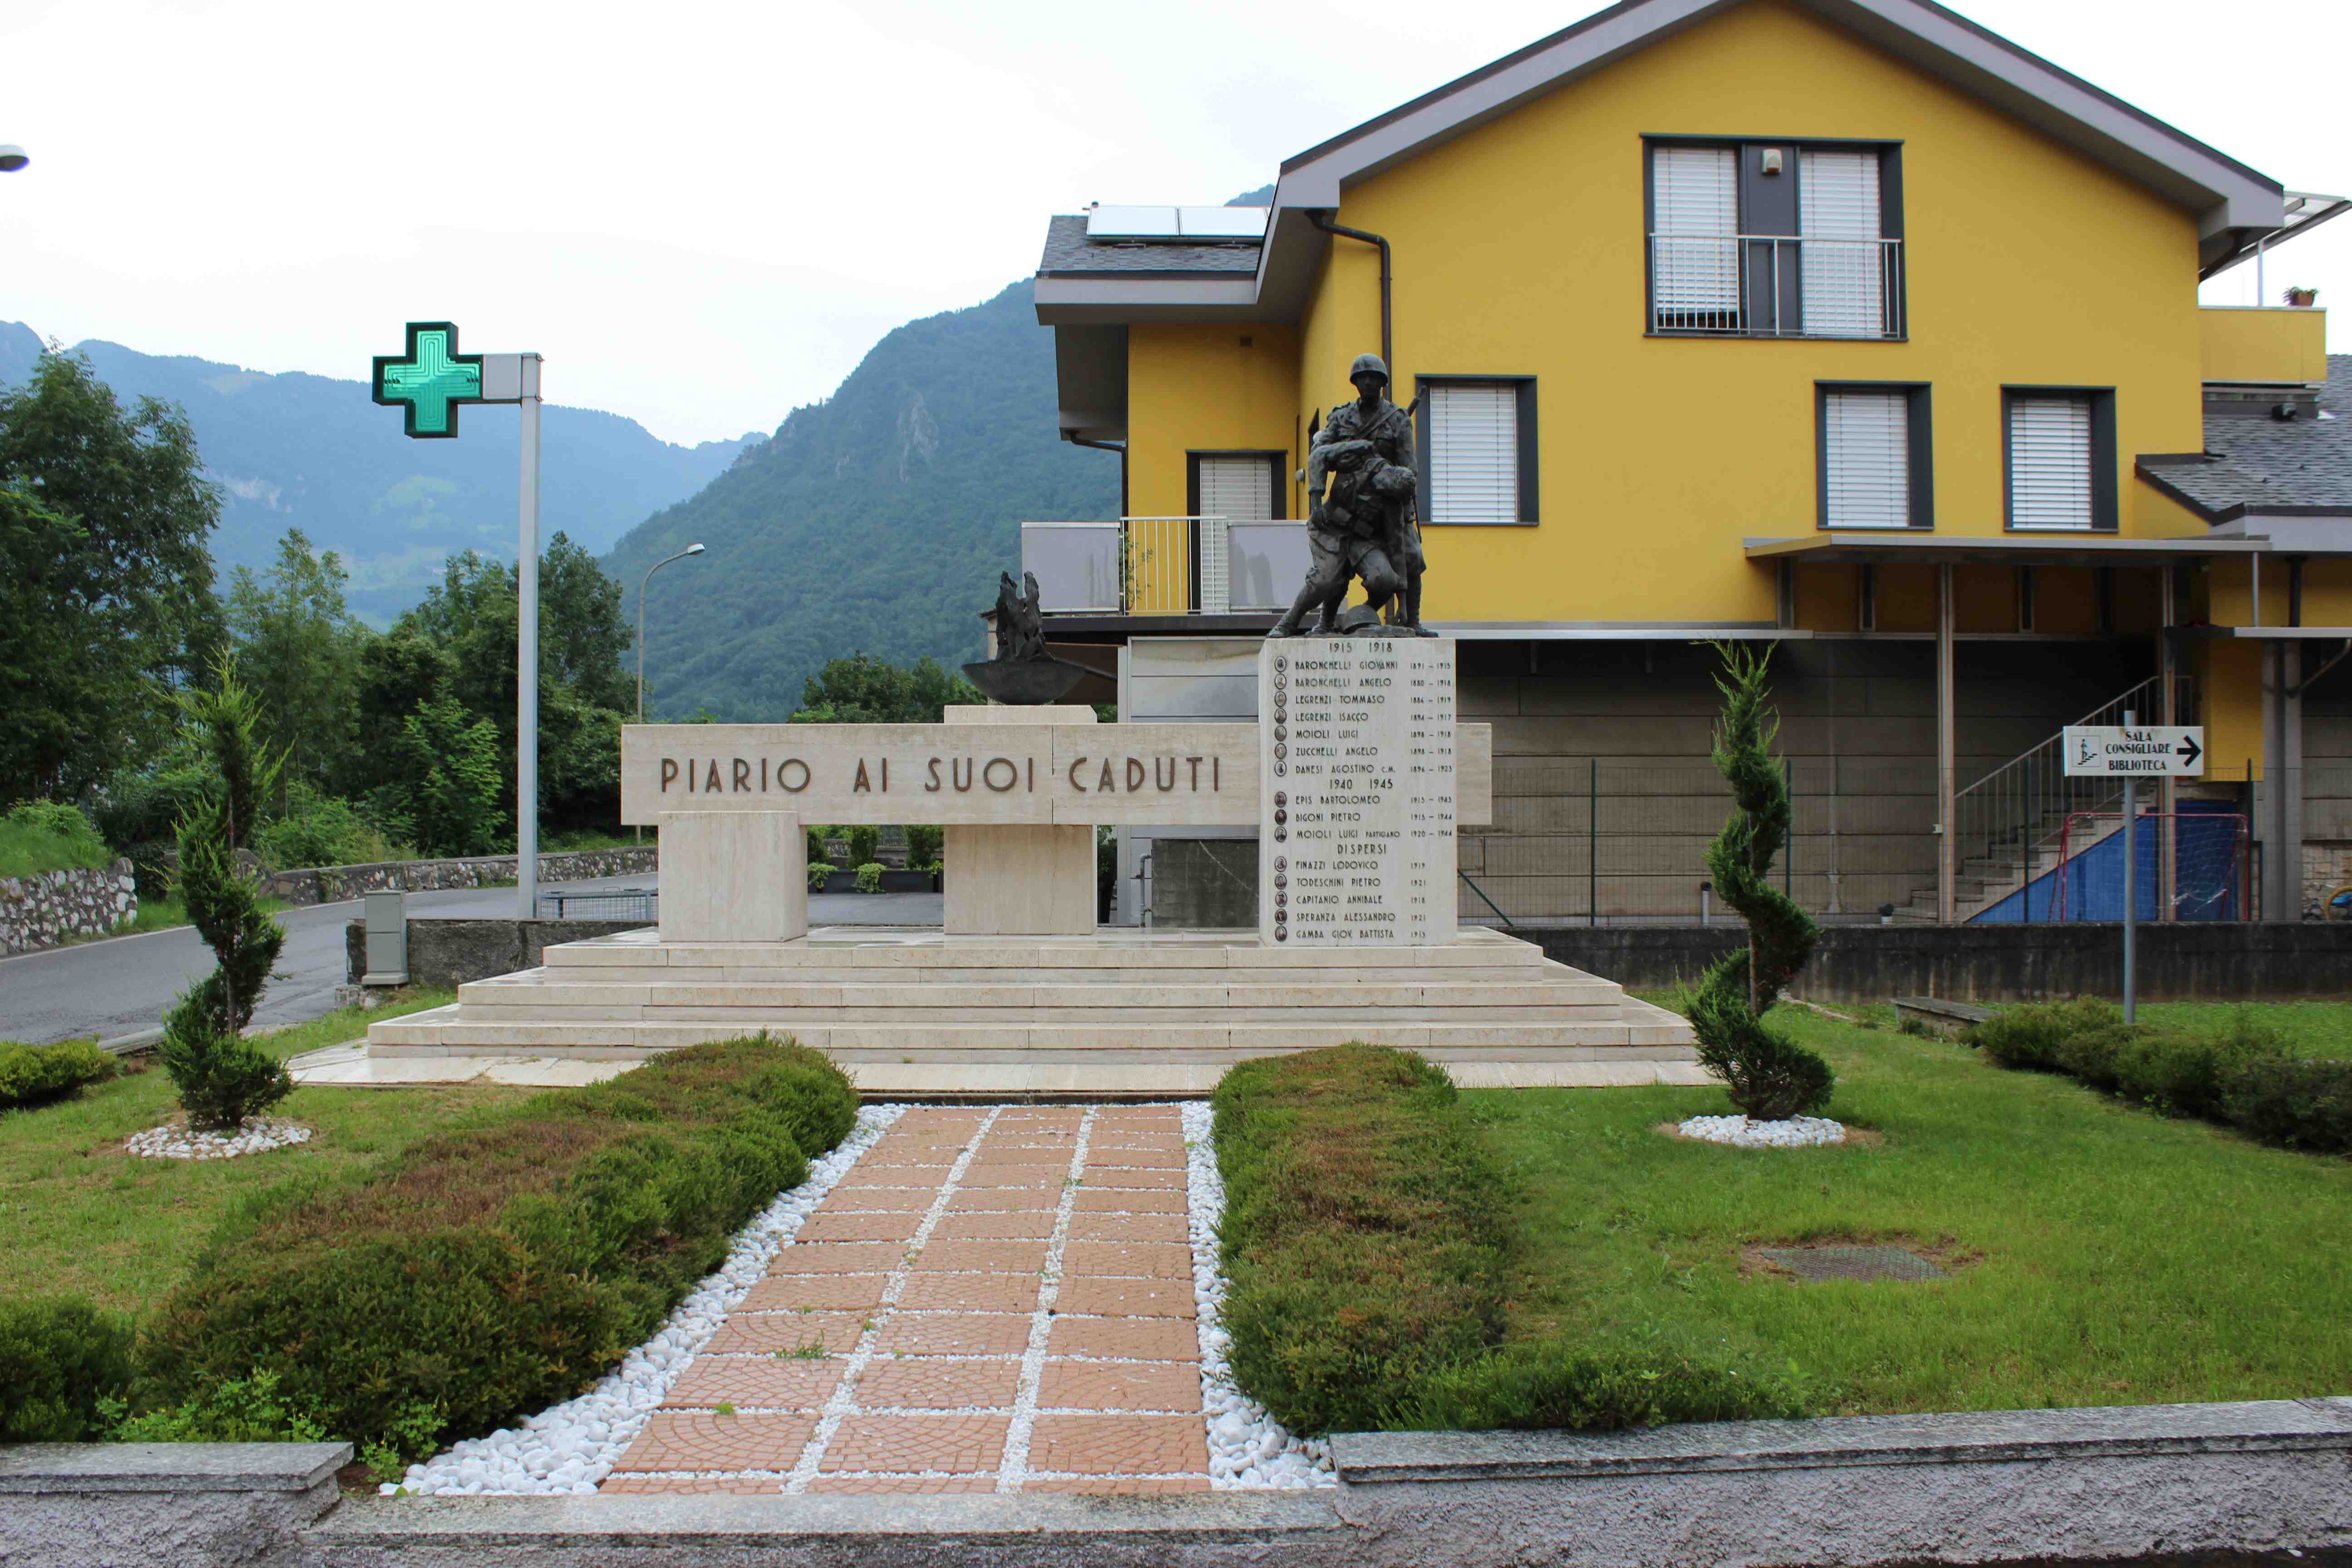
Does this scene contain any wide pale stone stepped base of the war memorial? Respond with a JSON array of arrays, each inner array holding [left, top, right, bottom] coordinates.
[[367, 926, 1696, 1093]]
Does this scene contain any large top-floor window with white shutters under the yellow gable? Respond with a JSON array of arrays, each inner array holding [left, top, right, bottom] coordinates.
[[1644, 137, 1907, 341]]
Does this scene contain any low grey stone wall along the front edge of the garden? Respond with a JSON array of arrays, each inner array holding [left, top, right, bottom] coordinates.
[[0, 1399, 2352, 1568]]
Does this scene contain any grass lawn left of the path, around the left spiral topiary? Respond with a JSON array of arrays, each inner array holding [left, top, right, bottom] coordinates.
[[0, 992, 532, 1312]]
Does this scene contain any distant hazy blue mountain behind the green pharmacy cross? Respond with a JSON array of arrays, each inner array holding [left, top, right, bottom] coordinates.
[[0, 322, 743, 625]]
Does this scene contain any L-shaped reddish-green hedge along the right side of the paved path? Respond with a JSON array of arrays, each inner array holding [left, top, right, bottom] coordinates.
[[1216, 1044, 1804, 1431]]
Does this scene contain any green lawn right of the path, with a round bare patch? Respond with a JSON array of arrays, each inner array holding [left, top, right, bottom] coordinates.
[[1463, 1004, 2352, 1413]]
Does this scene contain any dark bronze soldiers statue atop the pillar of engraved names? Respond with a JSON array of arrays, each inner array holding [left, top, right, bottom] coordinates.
[[1268, 355, 1437, 637]]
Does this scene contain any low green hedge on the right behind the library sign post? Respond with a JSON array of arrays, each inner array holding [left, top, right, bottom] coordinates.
[[1969, 997, 2352, 1154]]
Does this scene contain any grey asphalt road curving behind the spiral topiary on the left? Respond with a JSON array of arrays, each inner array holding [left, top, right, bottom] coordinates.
[[0, 872, 654, 1044]]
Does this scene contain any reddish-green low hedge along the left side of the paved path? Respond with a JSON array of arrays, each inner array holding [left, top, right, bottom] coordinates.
[[137, 1037, 856, 1450]]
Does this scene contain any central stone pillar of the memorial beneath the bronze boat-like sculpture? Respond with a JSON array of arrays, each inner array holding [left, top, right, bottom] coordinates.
[[941, 703, 1096, 936]]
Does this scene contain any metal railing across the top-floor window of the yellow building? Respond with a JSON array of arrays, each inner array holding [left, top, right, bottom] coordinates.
[[1649, 235, 1907, 338]]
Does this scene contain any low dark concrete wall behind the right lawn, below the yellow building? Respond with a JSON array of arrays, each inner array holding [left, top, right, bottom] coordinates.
[[1514, 921, 2352, 1004]]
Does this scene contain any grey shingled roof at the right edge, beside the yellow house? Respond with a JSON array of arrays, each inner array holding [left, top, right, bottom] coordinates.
[[2138, 355, 2352, 522]]
